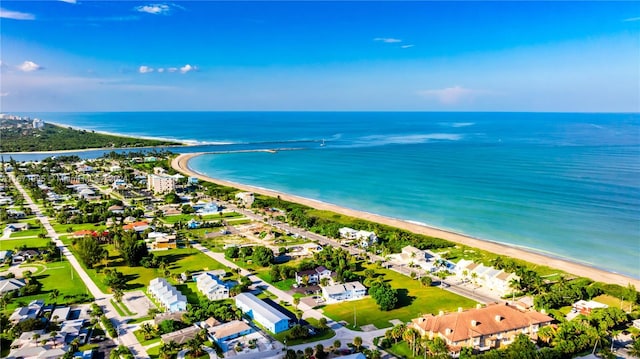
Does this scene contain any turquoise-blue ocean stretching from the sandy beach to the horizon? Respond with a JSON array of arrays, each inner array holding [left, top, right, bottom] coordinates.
[[14, 112, 640, 278]]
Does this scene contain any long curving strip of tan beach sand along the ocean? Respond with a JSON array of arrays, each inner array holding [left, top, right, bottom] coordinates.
[[171, 152, 640, 288]]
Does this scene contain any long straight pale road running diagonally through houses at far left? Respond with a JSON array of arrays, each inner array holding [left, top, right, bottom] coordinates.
[[9, 173, 149, 358]]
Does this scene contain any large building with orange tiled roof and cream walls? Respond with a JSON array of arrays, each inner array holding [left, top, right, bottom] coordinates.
[[409, 304, 553, 355]]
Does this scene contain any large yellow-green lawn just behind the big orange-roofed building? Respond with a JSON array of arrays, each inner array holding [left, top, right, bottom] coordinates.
[[323, 266, 476, 328]]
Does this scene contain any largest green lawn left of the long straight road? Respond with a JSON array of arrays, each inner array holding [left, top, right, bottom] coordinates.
[[5, 260, 89, 313]]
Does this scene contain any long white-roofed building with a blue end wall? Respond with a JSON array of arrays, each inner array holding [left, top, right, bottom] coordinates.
[[235, 293, 289, 334]]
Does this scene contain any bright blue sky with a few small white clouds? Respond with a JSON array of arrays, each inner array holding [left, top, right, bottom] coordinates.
[[0, 0, 640, 112]]
